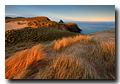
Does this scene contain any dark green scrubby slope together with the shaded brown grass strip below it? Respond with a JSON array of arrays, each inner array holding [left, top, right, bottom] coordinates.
[[5, 27, 78, 59]]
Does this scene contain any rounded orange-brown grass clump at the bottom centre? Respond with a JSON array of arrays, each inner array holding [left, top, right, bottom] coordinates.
[[53, 57, 84, 79]]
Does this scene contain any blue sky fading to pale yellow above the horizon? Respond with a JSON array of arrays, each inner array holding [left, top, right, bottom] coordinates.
[[5, 5, 115, 21]]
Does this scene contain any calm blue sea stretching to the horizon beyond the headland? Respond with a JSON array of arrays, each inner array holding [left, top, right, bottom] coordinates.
[[64, 21, 115, 34]]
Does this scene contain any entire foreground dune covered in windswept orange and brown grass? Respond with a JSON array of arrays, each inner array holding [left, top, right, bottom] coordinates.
[[5, 35, 115, 79]]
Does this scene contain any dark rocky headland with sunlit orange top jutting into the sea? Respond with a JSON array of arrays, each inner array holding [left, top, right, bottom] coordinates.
[[65, 23, 82, 32]]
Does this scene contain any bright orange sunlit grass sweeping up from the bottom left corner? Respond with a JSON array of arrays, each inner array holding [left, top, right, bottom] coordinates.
[[5, 44, 45, 79]]
